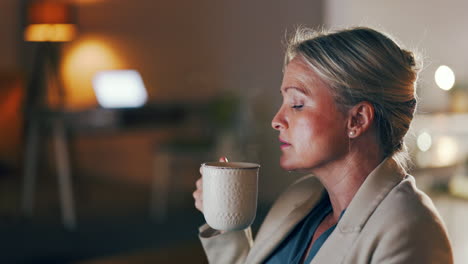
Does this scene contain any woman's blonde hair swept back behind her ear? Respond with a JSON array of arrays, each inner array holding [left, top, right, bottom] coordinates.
[[285, 27, 421, 168]]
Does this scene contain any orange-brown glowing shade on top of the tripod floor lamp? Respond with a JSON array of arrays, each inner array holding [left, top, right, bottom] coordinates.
[[24, 0, 76, 42]]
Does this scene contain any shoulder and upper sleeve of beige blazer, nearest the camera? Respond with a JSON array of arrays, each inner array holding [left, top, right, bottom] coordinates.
[[363, 176, 451, 263]]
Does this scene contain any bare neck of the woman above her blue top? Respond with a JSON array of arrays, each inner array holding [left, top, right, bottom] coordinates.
[[312, 144, 383, 221]]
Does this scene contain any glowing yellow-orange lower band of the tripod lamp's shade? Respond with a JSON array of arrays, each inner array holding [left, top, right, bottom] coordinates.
[[24, 24, 76, 42]]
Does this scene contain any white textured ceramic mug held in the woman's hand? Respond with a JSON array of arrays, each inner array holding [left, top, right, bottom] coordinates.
[[202, 162, 260, 231]]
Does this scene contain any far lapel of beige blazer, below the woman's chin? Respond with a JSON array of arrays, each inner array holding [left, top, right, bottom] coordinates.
[[245, 184, 323, 264]]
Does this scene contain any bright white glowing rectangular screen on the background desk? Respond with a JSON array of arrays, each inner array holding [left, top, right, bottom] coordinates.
[[93, 70, 148, 108]]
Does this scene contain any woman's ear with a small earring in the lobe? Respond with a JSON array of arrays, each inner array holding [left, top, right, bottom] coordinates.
[[347, 101, 375, 138]]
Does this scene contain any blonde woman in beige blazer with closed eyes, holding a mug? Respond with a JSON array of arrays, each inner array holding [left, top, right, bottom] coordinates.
[[194, 27, 453, 263]]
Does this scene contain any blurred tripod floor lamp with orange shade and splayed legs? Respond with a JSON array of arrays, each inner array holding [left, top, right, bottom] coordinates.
[[21, 0, 76, 229]]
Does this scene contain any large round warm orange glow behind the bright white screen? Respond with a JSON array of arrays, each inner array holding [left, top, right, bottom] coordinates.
[[61, 36, 125, 109]]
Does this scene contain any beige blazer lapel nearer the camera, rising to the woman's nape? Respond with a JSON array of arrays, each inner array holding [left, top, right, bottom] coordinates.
[[311, 158, 405, 264]]
